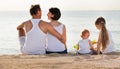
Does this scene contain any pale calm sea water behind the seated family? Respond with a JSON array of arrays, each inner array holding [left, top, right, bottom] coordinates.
[[0, 11, 120, 55]]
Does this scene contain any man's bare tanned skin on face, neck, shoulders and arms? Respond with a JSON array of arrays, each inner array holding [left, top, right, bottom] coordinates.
[[17, 11, 65, 43]]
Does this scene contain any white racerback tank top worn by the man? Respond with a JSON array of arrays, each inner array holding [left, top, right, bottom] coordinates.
[[22, 19, 47, 54]]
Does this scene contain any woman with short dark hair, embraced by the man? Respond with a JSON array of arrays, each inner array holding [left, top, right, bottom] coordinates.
[[46, 8, 67, 54]]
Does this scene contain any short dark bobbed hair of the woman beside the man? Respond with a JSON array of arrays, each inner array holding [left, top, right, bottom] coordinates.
[[49, 8, 61, 20]]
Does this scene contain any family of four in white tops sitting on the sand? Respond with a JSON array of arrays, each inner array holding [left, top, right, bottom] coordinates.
[[17, 4, 114, 55]]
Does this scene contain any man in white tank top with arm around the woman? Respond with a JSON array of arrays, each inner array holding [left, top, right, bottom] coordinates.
[[17, 5, 65, 54]]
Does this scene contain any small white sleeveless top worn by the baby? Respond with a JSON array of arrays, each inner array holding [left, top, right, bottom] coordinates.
[[78, 39, 91, 54]]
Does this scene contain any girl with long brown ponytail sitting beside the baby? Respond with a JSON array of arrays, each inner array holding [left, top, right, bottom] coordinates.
[[95, 17, 114, 54]]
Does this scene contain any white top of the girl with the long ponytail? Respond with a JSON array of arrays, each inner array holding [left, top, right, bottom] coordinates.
[[104, 30, 114, 53]]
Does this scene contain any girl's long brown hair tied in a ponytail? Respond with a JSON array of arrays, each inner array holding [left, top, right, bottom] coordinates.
[[95, 17, 109, 51]]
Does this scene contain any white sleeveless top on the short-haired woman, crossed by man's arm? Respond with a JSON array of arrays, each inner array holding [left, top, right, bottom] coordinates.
[[47, 24, 65, 52]]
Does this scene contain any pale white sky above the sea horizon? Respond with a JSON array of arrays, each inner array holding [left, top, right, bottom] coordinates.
[[0, 0, 120, 11]]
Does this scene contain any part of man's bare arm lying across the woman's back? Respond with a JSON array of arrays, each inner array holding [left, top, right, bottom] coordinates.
[[46, 24, 66, 43]]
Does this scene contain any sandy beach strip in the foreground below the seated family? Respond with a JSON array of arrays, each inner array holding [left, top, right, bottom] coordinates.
[[0, 53, 120, 69]]
